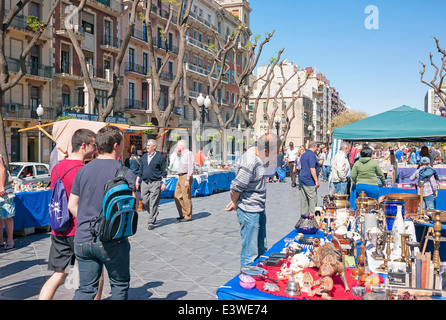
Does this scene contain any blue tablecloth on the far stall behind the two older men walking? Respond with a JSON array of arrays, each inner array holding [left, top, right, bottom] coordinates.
[[161, 171, 235, 198]]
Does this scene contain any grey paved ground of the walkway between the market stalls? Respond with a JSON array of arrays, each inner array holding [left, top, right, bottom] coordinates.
[[0, 178, 328, 300]]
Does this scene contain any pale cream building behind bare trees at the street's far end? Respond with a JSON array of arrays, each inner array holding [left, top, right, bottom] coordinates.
[[250, 61, 332, 145]]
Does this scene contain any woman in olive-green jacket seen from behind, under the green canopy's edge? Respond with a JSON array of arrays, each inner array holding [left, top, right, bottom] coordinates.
[[350, 146, 386, 201]]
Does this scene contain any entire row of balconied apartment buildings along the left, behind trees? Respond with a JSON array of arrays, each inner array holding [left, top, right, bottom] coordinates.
[[2, 0, 251, 162]]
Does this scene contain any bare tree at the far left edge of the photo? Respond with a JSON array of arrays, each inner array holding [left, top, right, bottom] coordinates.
[[0, 0, 60, 168]]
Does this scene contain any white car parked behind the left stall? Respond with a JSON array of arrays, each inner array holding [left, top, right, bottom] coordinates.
[[9, 162, 51, 186]]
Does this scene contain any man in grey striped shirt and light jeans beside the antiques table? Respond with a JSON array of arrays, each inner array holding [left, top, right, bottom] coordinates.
[[225, 133, 277, 267]]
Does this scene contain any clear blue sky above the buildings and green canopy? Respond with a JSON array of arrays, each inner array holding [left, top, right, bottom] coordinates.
[[250, 0, 446, 115]]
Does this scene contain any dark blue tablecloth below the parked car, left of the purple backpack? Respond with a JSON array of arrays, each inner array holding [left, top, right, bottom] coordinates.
[[13, 190, 51, 230]]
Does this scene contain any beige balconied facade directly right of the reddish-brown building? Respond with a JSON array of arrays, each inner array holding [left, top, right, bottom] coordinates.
[[119, 0, 179, 127]]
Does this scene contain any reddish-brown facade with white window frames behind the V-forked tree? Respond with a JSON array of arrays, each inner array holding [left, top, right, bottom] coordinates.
[[52, 0, 123, 120]]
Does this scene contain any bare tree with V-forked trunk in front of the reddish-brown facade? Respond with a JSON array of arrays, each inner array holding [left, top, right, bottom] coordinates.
[[64, 0, 140, 121]]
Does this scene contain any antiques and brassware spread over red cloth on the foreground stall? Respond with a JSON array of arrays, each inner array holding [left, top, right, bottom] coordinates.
[[240, 193, 446, 300]]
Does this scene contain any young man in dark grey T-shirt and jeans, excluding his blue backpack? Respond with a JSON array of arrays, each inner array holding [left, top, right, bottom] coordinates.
[[68, 126, 138, 300]]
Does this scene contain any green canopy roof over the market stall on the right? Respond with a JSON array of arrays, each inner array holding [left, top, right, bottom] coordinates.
[[333, 106, 446, 142]]
